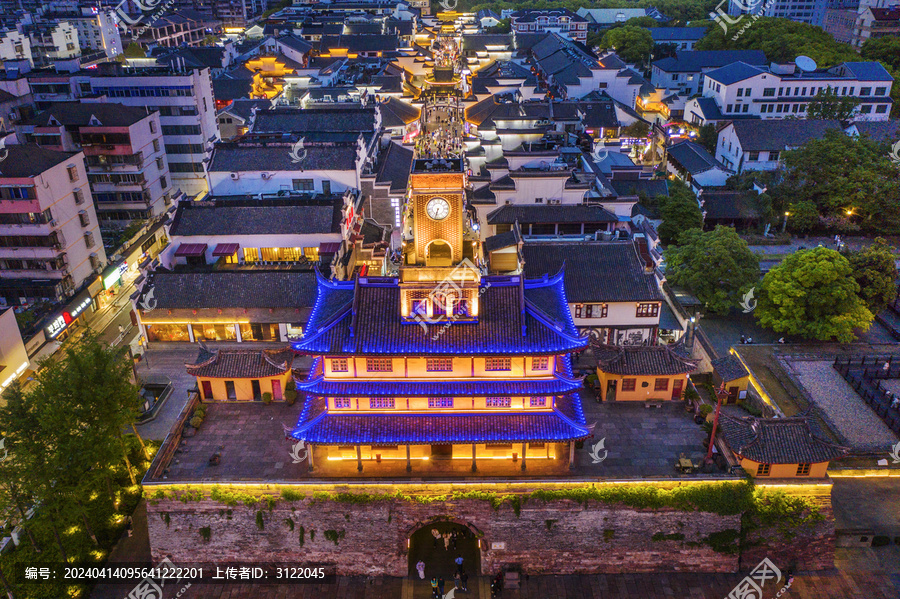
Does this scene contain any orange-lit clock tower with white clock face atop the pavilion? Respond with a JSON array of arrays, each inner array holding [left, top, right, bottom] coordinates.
[[400, 158, 481, 323]]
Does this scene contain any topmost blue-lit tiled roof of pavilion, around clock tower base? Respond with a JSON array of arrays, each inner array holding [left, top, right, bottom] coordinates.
[[293, 275, 586, 355]]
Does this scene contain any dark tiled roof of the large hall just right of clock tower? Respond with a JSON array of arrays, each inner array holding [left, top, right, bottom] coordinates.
[[523, 241, 662, 303]]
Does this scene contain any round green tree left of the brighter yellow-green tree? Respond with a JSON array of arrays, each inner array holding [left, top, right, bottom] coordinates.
[[666, 226, 759, 314]]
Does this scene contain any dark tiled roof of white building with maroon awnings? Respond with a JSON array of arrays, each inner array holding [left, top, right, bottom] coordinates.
[[169, 196, 343, 236]]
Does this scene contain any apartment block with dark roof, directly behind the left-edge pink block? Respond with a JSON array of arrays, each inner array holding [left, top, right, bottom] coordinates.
[[17, 102, 172, 228]]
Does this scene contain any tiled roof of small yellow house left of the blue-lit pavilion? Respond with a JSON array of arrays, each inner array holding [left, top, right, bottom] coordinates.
[[185, 346, 294, 379]]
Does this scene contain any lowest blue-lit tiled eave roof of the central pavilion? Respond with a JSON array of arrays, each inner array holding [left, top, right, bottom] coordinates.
[[291, 396, 589, 445]]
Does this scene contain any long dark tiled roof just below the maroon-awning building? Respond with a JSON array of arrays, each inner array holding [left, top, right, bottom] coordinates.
[[139, 270, 316, 309]]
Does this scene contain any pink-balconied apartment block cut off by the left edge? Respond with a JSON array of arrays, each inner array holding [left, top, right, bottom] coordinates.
[[0, 144, 106, 305]]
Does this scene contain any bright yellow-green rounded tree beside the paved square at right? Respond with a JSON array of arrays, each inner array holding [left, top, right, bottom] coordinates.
[[755, 247, 874, 343]]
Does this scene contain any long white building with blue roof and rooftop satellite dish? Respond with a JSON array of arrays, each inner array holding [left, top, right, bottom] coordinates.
[[684, 62, 894, 124]]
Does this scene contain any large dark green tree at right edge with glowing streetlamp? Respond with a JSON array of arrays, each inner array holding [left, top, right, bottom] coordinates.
[[777, 130, 900, 235]]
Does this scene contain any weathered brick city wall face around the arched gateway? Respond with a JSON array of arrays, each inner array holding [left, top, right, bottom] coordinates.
[[148, 499, 740, 576]]
